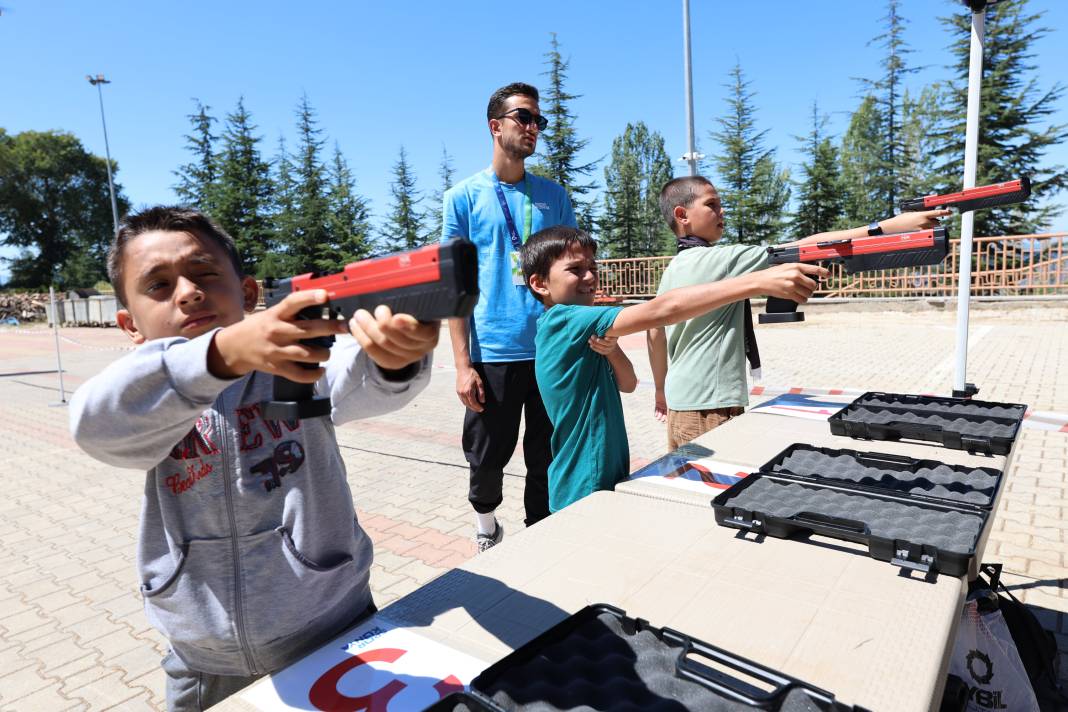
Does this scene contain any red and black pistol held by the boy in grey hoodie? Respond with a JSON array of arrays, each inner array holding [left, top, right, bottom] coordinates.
[[261, 240, 478, 421]]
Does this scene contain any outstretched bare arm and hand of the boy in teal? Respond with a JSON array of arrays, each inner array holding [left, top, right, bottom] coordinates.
[[606, 264, 828, 336]]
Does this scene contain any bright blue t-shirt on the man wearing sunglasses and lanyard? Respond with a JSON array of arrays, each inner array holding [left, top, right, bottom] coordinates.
[[441, 169, 576, 362]]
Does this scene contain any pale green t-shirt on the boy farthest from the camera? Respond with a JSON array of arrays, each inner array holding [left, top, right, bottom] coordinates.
[[657, 244, 768, 410]]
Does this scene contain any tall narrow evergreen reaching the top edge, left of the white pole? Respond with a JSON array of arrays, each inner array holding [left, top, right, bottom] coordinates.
[[862, 0, 920, 216]]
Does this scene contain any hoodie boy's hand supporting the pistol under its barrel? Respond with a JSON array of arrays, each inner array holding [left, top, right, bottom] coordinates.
[[348, 304, 441, 370]]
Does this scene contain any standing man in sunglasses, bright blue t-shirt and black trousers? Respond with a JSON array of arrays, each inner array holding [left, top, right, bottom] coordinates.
[[441, 83, 576, 552]]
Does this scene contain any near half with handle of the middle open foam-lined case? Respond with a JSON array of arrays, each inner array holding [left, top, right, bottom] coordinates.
[[712, 474, 990, 576]]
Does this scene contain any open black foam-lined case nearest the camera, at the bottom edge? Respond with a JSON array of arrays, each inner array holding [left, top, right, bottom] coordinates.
[[454, 604, 863, 712]]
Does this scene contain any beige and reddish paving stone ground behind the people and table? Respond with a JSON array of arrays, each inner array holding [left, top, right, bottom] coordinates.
[[0, 303, 1068, 711]]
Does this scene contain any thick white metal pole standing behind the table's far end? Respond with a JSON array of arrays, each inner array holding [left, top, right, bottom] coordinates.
[[953, 10, 987, 397]]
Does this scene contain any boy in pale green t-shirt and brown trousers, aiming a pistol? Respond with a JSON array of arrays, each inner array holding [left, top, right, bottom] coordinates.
[[647, 176, 949, 450]]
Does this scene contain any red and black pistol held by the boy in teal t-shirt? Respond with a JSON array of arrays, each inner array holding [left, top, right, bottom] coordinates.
[[760, 225, 949, 323]]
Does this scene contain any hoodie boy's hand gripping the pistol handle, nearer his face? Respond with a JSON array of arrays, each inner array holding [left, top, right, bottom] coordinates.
[[207, 289, 345, 383]]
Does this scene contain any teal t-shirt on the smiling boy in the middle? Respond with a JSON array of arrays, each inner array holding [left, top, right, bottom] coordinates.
[[534, 304, 630, 511]]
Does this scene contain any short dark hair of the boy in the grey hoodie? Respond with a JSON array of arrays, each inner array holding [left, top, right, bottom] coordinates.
[[108, 205, 245, 305]]
